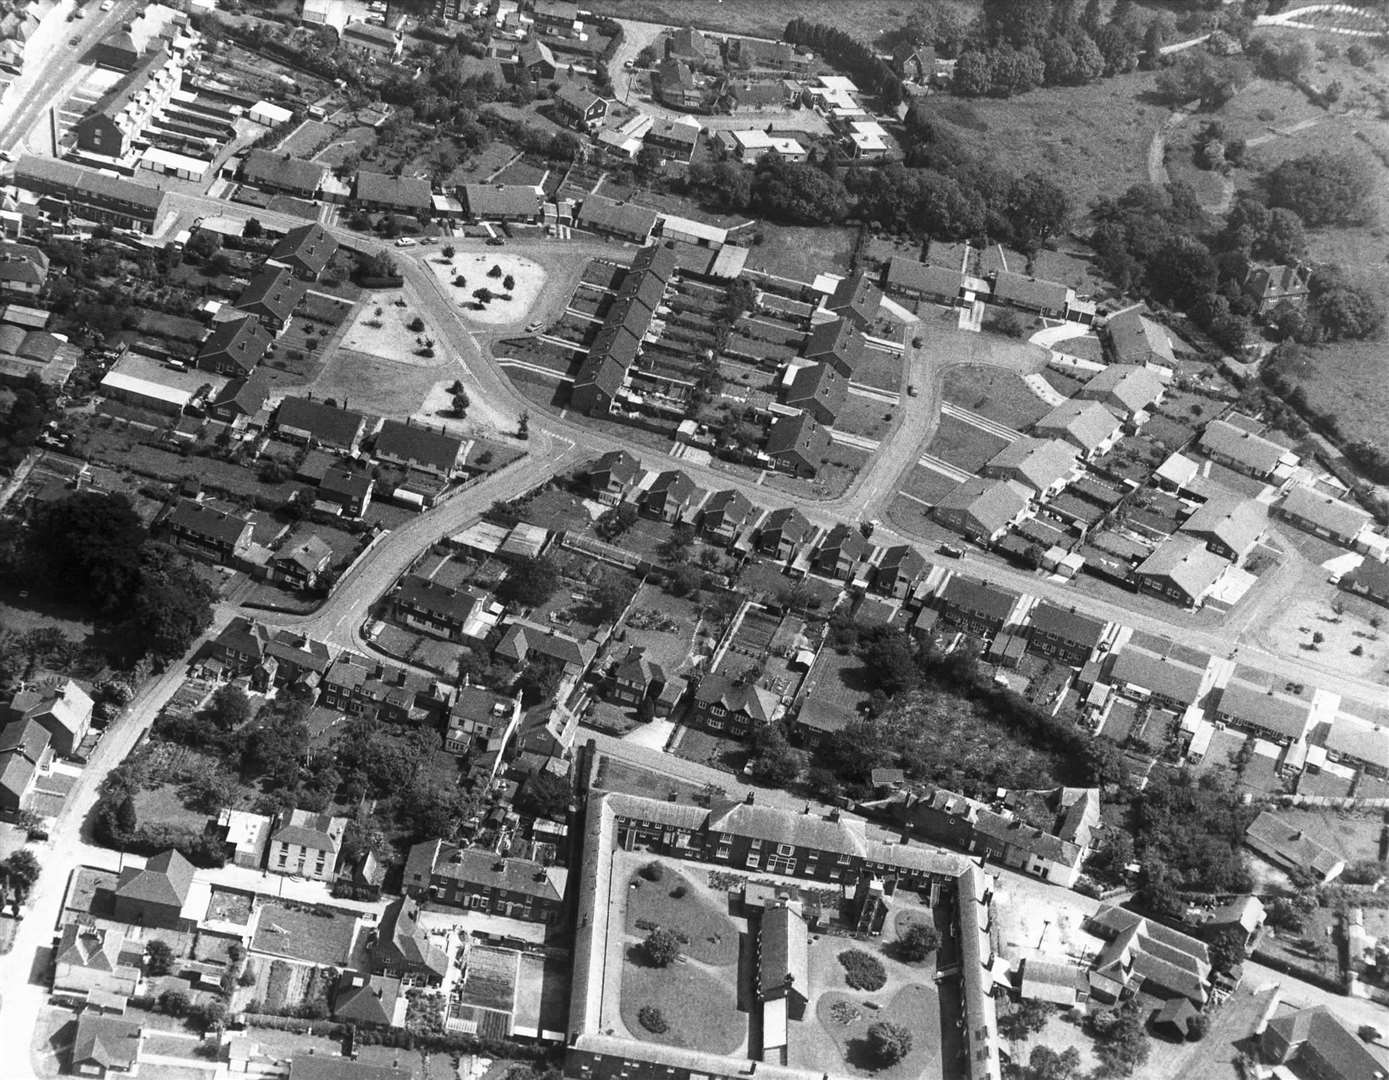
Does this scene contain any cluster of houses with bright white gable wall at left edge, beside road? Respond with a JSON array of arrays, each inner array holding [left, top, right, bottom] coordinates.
[[0, 679, 93, 812]]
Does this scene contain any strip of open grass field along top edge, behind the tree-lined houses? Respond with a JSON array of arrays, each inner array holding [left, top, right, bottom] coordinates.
[[589, 0, 975, 42]]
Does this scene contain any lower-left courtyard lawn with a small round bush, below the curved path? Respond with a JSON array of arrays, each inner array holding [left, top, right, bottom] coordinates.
[[619, 945, 747, 1055]]
